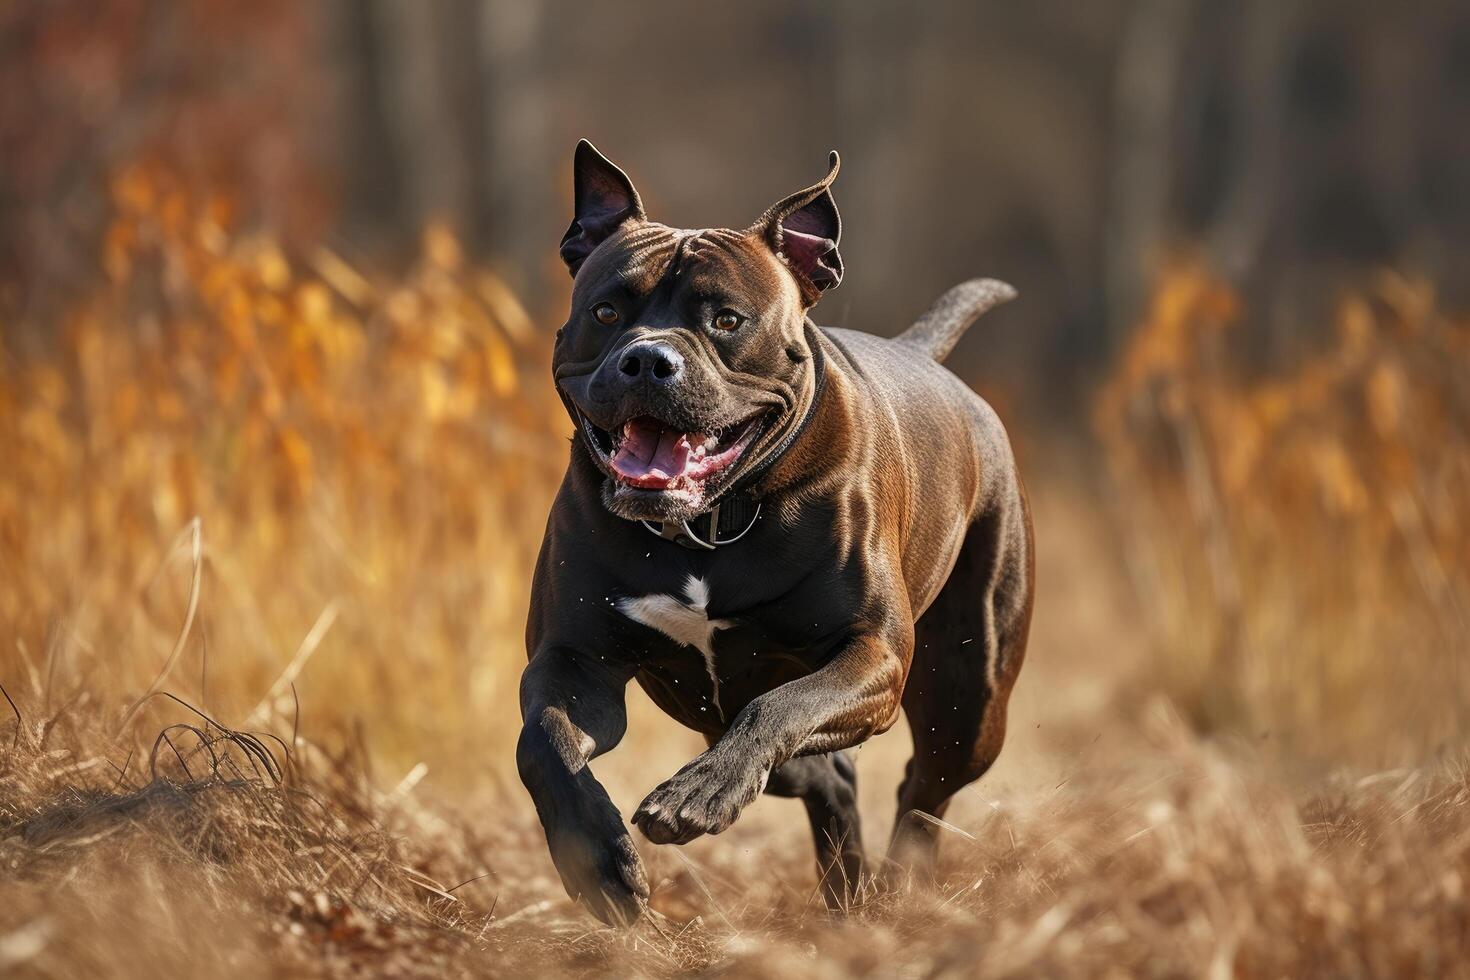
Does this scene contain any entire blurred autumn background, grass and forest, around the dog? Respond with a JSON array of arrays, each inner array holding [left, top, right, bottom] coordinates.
[[0, 0, 1470, 977]]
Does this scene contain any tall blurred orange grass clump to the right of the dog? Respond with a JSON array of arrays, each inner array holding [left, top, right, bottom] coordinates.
[[1097, 266, 1470, 765]]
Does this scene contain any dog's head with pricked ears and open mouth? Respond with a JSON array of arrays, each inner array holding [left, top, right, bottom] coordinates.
[[553, 140, 842, 520]]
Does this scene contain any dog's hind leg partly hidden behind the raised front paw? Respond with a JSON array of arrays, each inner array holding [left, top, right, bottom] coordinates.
[[766, 752, 863, 909]]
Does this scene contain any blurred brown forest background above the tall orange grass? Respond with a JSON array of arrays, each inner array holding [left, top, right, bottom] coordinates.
[[11, 0, 1470, 407]]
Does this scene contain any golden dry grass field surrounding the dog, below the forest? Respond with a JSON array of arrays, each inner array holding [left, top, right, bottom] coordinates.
[[0, 169, 1470, 977]]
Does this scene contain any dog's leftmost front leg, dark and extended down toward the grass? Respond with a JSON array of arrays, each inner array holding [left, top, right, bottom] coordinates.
[[516, 648, 648, 926]]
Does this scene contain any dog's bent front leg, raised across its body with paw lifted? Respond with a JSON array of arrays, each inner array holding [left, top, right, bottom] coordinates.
[[634, 627, 913, 843]]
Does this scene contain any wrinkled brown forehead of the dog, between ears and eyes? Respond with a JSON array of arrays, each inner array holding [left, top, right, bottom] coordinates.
[[575, 222, 794, 301]]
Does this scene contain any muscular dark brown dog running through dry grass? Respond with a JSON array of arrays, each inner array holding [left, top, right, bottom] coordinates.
[[516, 141, 1033, 923]]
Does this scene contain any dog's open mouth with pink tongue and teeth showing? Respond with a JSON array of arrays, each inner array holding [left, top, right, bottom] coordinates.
[[579, 413, 763, 491]]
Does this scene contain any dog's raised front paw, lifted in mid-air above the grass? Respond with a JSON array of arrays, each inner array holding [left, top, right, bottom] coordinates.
[[634, 749, 769, 843]]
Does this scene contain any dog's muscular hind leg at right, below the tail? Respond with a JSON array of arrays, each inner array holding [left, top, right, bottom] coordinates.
[[888, 495, 1032, 873]]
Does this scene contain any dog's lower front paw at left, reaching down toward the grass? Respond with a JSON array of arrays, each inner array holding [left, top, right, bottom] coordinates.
[[547, 805, 648, 926]]
